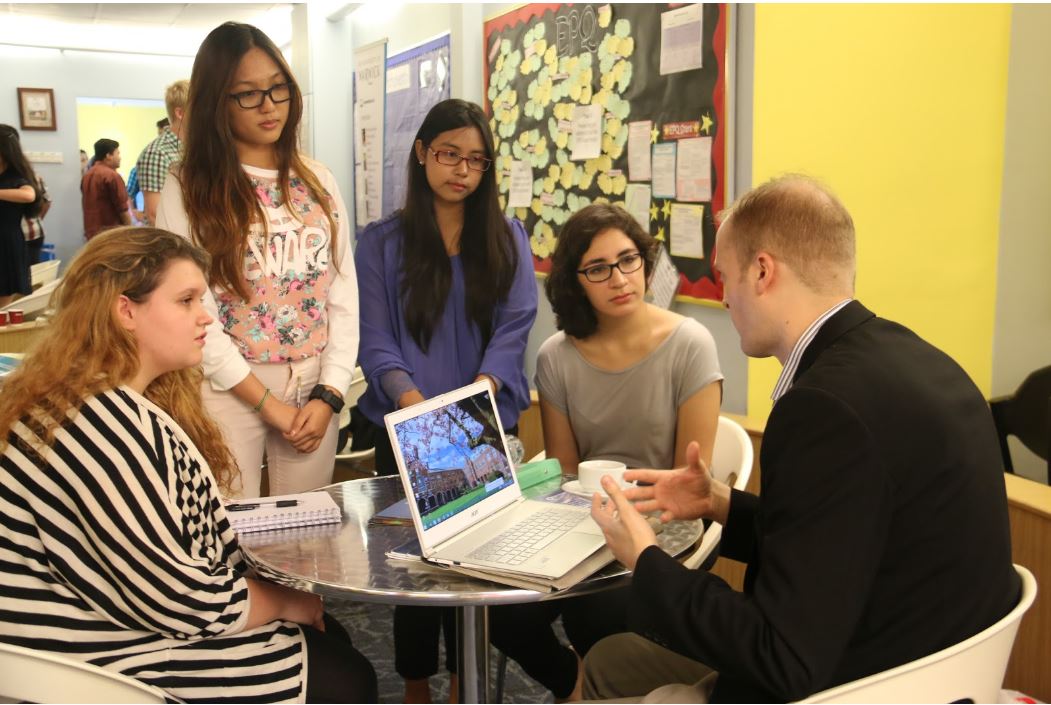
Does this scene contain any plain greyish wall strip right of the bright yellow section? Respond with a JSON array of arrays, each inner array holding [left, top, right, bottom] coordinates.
[[992, 4, 1051, 481]]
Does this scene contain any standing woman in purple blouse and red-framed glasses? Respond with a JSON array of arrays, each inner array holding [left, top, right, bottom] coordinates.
[[354, 100, 537, 702]]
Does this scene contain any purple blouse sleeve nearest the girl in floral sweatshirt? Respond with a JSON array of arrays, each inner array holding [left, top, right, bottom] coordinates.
[[354, 221, 413, 385]]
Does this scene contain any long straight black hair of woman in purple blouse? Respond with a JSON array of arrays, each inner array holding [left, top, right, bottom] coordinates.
[[400, 99, 518, 352]]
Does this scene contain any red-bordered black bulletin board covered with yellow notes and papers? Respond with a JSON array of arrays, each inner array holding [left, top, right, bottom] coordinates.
[[483, 3, 731, 303]]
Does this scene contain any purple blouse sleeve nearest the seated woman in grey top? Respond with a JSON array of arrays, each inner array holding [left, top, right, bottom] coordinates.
[[478, 220, 537, 416]]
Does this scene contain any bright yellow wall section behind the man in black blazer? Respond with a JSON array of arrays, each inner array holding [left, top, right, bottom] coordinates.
[[748, 4, 1011, 416]]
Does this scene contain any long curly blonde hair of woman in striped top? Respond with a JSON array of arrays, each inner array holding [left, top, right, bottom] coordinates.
[[0, 227, 239, 493]]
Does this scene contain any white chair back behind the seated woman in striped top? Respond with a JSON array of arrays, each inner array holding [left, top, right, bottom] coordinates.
[[0, 643, 167, 703]]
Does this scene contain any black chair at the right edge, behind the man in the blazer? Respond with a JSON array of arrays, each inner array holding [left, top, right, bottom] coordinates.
[[989, 366, 1051, 484]]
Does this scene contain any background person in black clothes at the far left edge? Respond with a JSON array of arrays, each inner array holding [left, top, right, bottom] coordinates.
[[0, 125, 43, 306]]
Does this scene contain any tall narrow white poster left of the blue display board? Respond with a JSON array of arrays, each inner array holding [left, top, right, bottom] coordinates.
[[354, 39, 387, 228]]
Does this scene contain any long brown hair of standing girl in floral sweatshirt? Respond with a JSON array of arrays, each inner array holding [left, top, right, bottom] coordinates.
[[179, 22, 336, 300]]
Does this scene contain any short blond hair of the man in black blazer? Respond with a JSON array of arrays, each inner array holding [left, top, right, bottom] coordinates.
[[720, 174, 856, 293]]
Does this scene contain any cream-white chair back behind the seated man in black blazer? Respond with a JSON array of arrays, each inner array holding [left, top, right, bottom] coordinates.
[[801, 565, 1036, 703]]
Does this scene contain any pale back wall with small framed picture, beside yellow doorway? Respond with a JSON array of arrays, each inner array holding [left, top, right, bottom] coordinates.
[[0, 46, 193, 267]]
